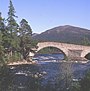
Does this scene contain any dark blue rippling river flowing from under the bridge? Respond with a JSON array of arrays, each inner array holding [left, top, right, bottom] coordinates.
[[0, 54, 90, 91]]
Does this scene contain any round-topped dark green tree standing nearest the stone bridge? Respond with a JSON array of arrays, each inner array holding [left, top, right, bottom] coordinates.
[[19, 19, 37, 60]]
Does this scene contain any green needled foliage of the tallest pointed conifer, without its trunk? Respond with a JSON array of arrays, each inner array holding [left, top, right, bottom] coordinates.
[[7, 0, 19, 51]]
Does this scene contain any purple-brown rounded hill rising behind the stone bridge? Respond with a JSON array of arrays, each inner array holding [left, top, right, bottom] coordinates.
[[33, 25, 90, 44]]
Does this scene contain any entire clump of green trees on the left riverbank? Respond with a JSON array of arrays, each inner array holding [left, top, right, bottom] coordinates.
[[0, 0, 37, 64]]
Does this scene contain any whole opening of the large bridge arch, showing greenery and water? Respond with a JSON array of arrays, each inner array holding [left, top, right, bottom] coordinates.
[[34, 46, 66, 61]]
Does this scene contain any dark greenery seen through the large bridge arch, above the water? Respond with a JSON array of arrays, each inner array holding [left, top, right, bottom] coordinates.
[[34, 46, 67, 59]]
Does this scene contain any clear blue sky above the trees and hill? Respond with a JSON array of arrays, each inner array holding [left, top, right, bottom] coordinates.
[[0, 0, 90, 33]]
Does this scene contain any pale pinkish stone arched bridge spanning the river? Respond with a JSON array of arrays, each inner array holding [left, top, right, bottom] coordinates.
[[37, 42, 90, 57]]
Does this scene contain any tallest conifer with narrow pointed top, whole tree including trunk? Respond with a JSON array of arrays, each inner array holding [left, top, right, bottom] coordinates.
[[5, 0, 19, 60]]
